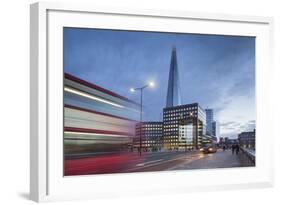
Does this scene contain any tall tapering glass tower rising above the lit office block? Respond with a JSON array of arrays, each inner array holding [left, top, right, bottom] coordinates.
[[166, 47, 181, 107]]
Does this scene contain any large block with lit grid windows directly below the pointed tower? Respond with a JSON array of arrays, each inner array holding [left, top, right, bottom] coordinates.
[[163, 103, 206, 150]]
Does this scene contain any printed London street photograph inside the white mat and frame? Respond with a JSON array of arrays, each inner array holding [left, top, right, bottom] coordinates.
[[63, 27, 256, 176]]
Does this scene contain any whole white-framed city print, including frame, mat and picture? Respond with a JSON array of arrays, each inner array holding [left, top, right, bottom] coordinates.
[[30, 3, 273, 201]]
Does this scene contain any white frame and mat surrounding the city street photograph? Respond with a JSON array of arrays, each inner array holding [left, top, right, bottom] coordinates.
[[30, 2, 273, 202]]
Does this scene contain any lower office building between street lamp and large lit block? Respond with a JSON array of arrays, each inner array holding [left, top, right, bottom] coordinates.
[[134, 122, 163, 151]]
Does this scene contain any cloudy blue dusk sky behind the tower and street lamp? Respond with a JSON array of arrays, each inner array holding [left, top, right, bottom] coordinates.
[[64, 28, 256, 138]]
